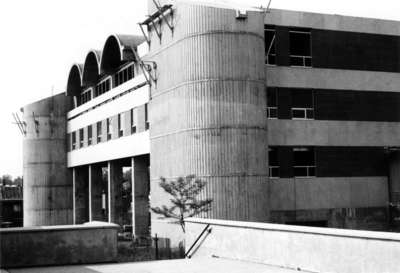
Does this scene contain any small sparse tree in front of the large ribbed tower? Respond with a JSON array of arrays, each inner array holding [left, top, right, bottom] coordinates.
[[151, 175, 212, 232]]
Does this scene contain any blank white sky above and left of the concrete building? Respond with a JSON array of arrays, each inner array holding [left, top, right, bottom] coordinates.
[[0, 0, 400, 177]]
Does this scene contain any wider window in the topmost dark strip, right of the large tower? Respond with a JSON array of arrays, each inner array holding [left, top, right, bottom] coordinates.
[[289, 30, 312, 67]]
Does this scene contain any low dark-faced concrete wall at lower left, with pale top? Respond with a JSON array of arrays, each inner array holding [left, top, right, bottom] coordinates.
[[0, 222, 118, 268]]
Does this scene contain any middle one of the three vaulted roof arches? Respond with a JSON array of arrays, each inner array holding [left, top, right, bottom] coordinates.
[[82, 50, 101, 86]]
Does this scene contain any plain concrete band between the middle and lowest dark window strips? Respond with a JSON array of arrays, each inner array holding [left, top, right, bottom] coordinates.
[[268, 119, 400, 147]]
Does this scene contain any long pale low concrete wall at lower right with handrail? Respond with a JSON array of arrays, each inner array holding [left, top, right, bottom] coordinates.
[[186, 218, 400, 273]]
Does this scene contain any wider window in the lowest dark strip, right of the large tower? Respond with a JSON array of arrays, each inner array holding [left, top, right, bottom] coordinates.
[[293, 148, 315, 177]]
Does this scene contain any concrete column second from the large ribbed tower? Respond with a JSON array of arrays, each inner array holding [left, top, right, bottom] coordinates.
[[108, 161, 123, 225]]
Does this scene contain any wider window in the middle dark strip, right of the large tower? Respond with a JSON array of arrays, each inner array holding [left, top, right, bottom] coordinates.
[[292, 90, 314, 119]]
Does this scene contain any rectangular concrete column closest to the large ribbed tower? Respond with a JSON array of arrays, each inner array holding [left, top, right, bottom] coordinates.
[[132, 156, 150, 237]]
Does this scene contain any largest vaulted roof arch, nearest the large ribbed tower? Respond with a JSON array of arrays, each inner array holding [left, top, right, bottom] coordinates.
[[100, 34, 144, 73]]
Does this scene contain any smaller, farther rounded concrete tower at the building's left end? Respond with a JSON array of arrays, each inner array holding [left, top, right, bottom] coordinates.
[[23, 94, 72, 226]]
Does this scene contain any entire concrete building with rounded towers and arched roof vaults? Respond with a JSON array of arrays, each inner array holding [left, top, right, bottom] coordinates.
[[24, 1, 400, 249]]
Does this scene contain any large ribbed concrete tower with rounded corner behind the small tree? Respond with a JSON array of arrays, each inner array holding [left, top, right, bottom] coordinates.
[[148, 1, 269, 242]]
